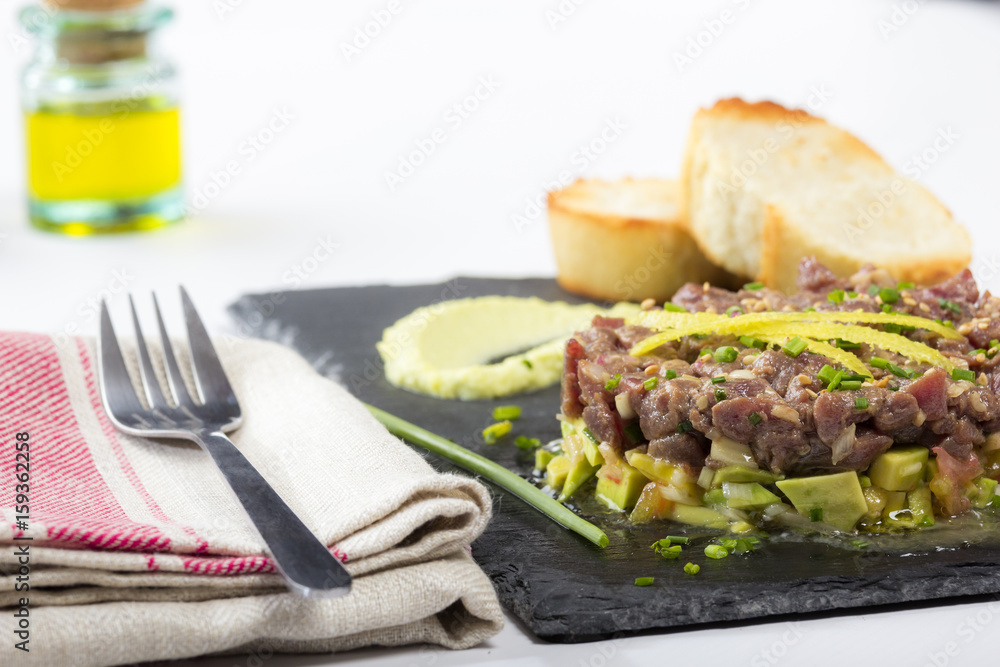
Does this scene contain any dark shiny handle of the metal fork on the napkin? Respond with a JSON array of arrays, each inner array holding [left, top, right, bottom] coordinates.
[[194, 431, 351, 598]]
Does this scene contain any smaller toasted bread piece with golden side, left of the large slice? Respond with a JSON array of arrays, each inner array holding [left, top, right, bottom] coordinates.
[[549, 179, 732, 301]]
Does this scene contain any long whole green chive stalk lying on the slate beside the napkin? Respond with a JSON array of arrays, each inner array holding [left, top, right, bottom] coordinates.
[[365, 404, 608, 549]]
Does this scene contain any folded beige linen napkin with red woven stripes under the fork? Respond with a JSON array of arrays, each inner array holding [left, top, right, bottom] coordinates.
[[0, 333, 503, 667]]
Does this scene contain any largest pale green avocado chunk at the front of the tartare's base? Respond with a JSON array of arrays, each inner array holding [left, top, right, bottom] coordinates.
[[775, 472, 868, 530]]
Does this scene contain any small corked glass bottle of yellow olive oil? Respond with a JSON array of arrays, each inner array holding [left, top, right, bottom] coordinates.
[[20, 0, 184, 235]]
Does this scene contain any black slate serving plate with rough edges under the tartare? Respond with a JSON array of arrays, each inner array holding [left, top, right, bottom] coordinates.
[[230, 278, 1000, 642]]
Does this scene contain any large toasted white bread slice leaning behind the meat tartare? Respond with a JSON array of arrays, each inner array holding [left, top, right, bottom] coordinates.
[[681, 99, 971, 292]]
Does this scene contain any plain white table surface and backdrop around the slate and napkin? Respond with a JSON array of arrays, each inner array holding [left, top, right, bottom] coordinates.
[[0, 0, 1000, 667]]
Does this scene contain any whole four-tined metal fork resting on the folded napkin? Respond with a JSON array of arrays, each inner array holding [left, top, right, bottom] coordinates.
[[97, 287, 351, 597]]
